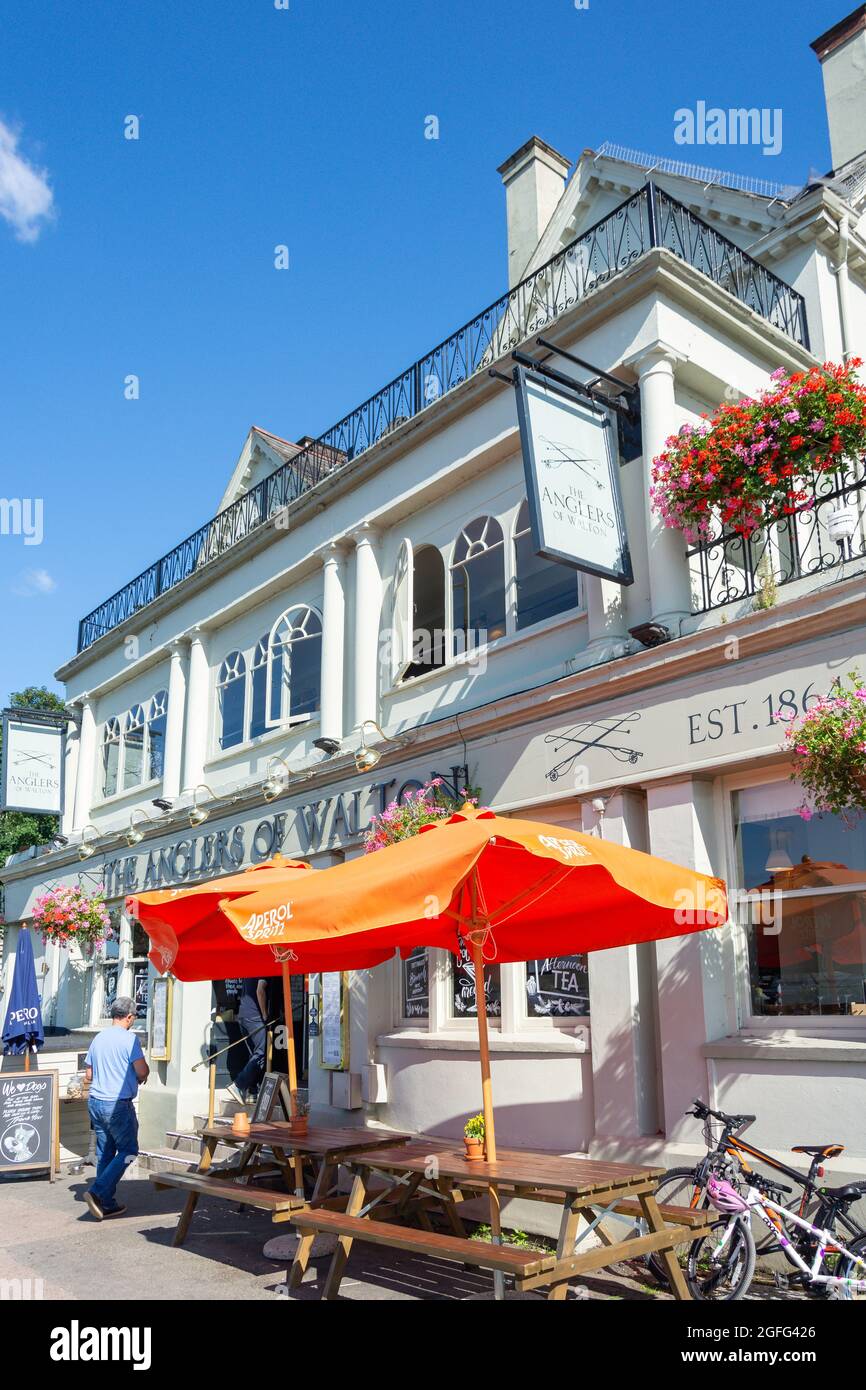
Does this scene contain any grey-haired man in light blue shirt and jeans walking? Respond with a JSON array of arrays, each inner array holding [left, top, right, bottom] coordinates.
[[85, 997, 150, 1220]]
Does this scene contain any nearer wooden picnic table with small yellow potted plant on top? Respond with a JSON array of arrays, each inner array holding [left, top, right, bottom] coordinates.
[[288, 1140, 708, 1300]]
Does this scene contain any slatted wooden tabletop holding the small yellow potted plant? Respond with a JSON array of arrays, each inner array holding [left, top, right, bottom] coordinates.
[[343, 1140, 662, 1193]]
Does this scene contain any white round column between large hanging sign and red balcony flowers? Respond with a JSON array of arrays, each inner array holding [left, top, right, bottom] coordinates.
[[635, 346, 691, 637]]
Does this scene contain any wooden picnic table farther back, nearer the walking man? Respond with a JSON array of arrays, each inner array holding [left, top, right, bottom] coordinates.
[[150, 1120, 410, 1245]]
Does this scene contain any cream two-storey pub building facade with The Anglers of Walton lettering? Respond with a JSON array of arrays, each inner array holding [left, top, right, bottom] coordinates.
[[3, 7, 866, 1175]]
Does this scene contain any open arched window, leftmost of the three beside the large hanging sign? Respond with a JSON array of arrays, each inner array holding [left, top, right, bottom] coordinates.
[[393, 539, 445, 682]]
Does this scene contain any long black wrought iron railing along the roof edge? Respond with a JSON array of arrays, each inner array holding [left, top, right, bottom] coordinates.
[[78, 183, 809, 652]]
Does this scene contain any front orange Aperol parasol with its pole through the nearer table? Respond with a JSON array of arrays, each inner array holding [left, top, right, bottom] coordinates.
[[222, 806, 727, 1251]]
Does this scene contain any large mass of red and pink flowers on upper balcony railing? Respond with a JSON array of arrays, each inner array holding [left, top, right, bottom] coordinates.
[[649, 357, 866, 543]]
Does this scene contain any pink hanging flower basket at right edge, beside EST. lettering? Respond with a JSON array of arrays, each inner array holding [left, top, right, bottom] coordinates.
[[785, 671, 866, 820]]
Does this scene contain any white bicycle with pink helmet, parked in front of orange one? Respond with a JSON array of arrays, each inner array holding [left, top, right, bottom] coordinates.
[[695, 1172, 866, 1301]]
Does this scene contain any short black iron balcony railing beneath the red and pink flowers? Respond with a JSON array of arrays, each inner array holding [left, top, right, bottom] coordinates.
[[688, 459, 866, 613]]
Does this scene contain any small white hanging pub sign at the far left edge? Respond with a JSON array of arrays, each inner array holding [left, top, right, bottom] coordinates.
[[0, 709, 65, 816]]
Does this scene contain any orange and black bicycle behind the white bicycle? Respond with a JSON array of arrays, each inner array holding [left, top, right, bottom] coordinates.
[[646, 1099, 866, 1300]]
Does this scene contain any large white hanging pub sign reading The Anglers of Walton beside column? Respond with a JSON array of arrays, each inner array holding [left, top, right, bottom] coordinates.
[[513, 367, 634, 584]]
